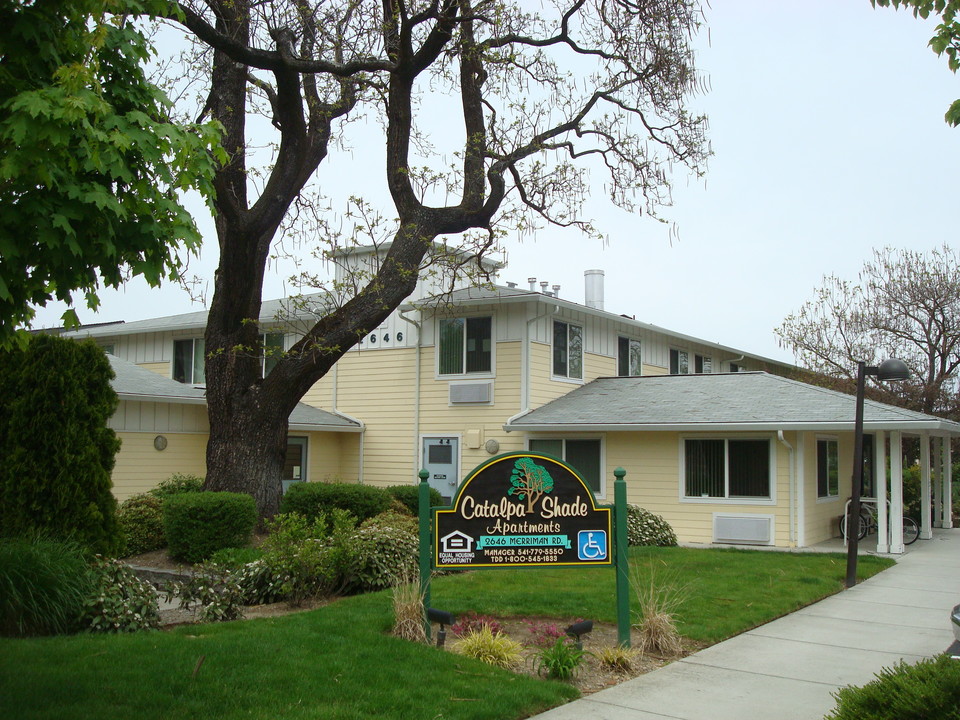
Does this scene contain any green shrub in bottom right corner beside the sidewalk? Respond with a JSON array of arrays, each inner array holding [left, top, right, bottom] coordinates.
[[825, 655, 960, 720]]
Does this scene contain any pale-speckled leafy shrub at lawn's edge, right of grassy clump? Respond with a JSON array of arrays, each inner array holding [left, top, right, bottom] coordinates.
[[83, 556, 160, 633]]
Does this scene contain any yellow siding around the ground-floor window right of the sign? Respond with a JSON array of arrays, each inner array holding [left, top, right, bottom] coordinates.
[[606, 432, 790, 547]]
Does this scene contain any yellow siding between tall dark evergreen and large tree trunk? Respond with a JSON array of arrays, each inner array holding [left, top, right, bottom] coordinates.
[[111, 432, 207, 501]]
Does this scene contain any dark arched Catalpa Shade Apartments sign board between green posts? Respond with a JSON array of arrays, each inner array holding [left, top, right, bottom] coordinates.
[[433, 452, 613, 568]]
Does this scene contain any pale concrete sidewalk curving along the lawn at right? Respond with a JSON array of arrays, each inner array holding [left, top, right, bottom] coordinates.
[[534, 529, 960, 720]]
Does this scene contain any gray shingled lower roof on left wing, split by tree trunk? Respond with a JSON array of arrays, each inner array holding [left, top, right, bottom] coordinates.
[[107, 355, 363, 432]]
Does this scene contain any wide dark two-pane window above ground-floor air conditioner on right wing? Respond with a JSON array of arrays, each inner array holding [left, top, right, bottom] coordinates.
[[683, 438, 771, 499]]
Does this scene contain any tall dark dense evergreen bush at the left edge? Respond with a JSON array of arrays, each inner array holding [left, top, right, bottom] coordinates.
[[0, 335, 121, 553]]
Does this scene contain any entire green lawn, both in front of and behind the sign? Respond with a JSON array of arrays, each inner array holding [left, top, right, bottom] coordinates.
[[0, 548, 890, 720]]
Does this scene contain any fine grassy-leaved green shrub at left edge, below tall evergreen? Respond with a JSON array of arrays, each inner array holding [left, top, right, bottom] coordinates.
[[0, 535, 93, 637]]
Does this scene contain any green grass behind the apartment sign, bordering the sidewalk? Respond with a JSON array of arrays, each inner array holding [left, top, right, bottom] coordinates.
[[431, 547, 893, 643]]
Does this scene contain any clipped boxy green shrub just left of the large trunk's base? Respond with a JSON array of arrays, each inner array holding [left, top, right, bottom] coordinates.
[[163, 492, 257, 563]]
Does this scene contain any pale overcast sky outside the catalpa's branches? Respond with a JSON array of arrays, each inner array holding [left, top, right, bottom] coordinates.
[[34, 0, 960, 362]]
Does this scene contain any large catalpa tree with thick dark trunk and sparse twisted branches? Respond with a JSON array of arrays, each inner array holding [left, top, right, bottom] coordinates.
[[163, 0, 705, 515]]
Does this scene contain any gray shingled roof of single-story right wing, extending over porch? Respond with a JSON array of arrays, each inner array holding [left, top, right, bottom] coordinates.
[[504, 372, 960, 435]]
